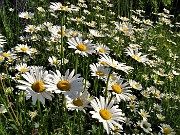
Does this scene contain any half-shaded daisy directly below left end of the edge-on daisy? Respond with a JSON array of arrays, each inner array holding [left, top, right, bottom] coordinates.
[[90, 63, 110, 79]]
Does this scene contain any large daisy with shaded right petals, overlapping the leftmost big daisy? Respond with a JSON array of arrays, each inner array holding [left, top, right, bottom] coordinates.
[[45, 69, 83, 94]]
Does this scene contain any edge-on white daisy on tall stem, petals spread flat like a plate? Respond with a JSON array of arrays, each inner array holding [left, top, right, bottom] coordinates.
[[99, 54, 133, 73]]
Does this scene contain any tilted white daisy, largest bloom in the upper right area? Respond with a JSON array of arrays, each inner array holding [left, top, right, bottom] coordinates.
[[125, 47, 149, 63]]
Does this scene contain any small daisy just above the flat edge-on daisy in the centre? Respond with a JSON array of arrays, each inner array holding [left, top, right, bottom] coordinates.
[[96, 43, 110, 55]]
